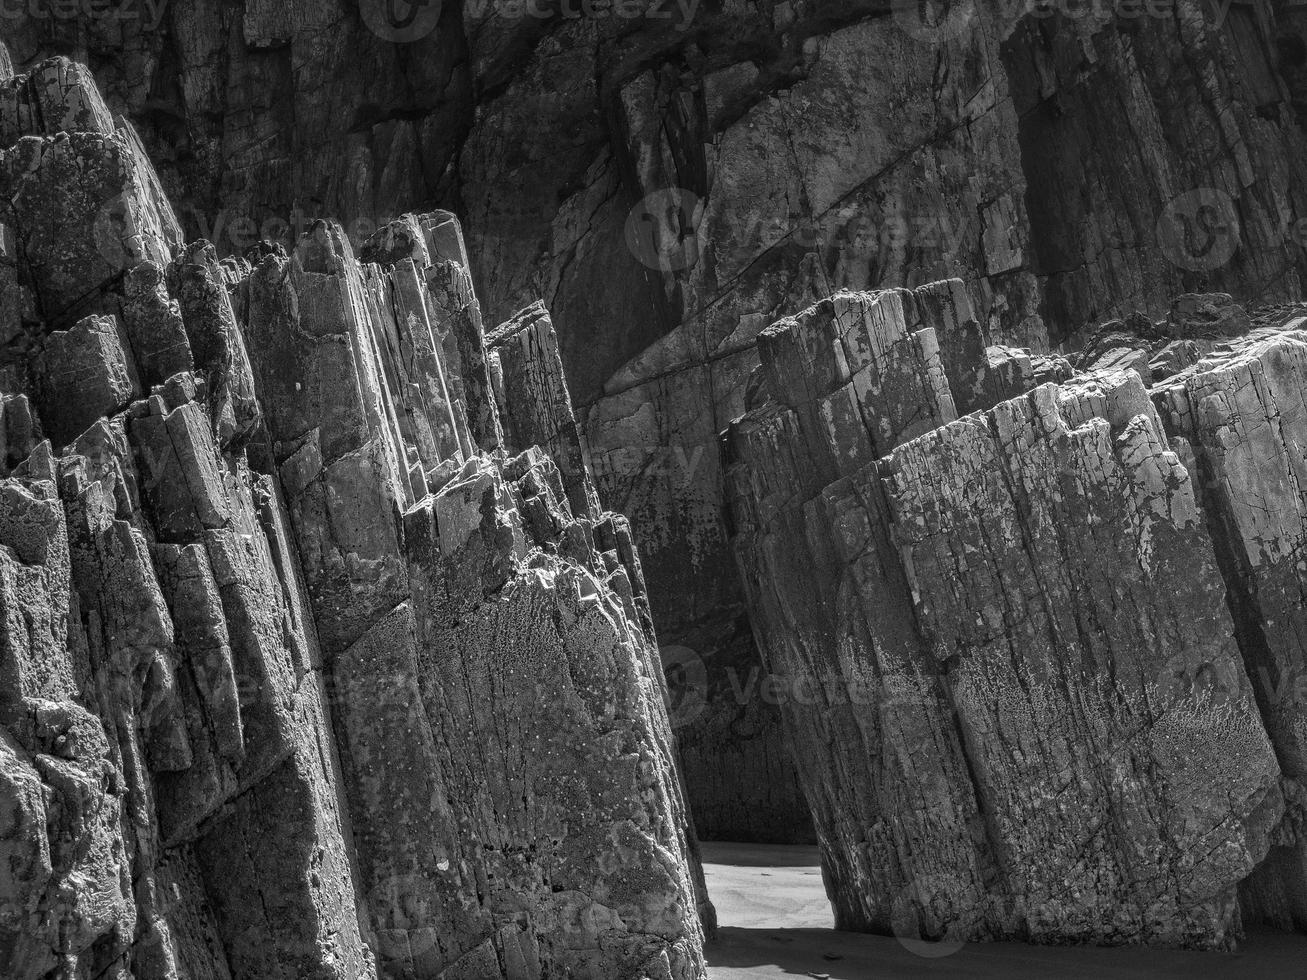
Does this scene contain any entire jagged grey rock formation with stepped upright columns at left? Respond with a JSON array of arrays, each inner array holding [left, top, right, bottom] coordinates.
[[0, 61, 711, 980]]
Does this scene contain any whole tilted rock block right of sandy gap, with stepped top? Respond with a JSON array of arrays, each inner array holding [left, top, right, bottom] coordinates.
[[728, 291, 1297, 946]]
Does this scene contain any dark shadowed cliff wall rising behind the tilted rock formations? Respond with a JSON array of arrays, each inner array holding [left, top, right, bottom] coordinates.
[[15, 0, 1304, 832]]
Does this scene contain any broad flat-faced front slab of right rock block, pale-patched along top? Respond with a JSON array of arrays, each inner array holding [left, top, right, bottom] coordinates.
[[882, 372, 1282, 947]]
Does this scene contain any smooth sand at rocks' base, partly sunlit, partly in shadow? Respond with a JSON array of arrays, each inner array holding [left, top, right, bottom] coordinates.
[[702, 843, 1307, 980]]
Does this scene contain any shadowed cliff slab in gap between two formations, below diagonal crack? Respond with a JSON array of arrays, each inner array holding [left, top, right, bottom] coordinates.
[[582, 327, 813, 841]]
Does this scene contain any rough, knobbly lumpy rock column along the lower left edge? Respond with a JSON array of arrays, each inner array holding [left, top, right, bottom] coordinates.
[[0, 418, 135, 980]]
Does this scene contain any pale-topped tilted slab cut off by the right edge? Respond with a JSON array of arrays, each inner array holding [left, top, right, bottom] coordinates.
[[1153, 331, 1307, 929]]
